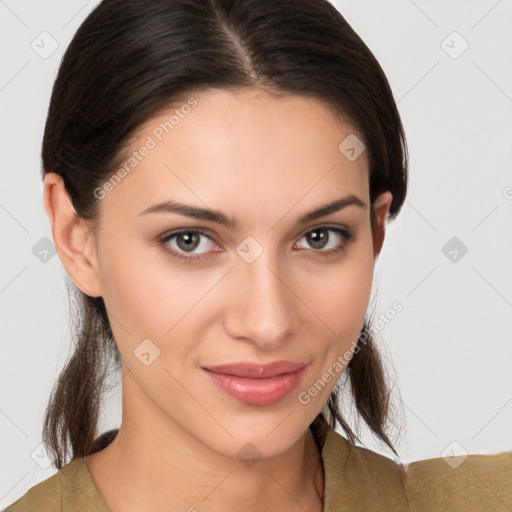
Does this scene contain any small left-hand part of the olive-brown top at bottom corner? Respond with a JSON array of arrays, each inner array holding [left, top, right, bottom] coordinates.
[[4, 458, 108, 512]]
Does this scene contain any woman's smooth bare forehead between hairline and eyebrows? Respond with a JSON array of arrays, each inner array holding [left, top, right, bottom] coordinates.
[[97, 89, 368, 226]]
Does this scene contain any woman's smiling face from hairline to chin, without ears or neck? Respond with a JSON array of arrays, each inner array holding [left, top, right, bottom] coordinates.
[[84, 89, 391, 457]]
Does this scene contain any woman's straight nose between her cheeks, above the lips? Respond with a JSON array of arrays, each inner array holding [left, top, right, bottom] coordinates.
[[225, 251, 300, 350]]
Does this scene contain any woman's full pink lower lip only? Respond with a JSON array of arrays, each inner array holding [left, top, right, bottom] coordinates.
[[202, 367, 306, 405]]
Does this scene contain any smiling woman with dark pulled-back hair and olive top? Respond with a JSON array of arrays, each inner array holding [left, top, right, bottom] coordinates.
[[7, 0, 512, 512]]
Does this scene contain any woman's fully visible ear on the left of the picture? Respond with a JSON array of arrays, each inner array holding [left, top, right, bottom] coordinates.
[[44, 172, 102, 297]]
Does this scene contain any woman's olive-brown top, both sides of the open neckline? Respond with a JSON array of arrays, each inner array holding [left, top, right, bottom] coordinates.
[[5, 429, 512, 512]]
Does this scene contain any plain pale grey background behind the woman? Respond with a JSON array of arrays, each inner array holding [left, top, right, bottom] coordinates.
[[0, 0, 512, 508]]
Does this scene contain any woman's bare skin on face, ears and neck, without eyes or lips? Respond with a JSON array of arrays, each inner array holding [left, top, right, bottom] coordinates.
[[44, 89, 392, 512]]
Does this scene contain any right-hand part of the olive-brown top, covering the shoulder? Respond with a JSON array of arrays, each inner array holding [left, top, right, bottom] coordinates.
[[322, 430, 512, 512]]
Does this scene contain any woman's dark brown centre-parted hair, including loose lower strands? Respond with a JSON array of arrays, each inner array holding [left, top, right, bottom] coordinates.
[[42, 0, 408, 469]]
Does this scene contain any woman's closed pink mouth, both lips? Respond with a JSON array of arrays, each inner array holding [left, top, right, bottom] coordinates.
[[201, 361, 307, 406]]
